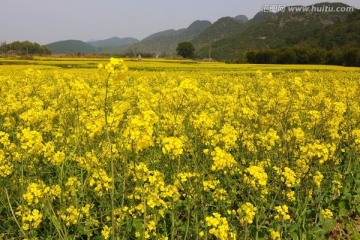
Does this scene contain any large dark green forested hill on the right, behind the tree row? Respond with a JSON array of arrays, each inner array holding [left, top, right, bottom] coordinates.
[[193, 3, 360, 60]]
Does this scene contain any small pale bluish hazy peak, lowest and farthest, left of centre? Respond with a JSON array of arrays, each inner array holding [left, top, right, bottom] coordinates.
[[87, 37, 139, 53]]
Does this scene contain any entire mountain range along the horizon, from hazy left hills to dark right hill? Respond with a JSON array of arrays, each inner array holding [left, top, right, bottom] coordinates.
[[47, 2, 360, 60]]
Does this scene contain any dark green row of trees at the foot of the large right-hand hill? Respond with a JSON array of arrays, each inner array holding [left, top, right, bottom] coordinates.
[[246, 47, 360, 67]]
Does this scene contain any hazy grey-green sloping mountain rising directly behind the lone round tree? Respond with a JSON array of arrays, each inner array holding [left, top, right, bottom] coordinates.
[[124, 20, 211, 56]]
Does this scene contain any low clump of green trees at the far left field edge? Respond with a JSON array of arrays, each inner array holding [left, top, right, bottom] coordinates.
[[0, 41, 51, 55]]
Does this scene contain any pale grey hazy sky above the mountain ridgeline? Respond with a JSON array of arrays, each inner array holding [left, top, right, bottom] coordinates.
[[0, 0, 360, 44]]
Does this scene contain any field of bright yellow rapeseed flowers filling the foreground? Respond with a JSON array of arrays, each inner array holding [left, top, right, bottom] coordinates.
[[0, 58, 360, 240]]
